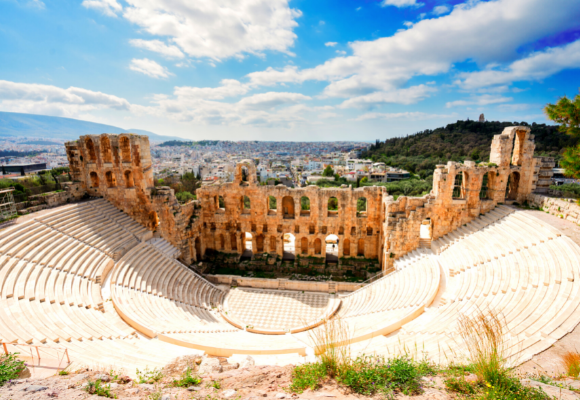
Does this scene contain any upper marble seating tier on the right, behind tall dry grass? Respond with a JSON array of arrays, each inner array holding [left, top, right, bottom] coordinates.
[[346, 210, 580, 363]]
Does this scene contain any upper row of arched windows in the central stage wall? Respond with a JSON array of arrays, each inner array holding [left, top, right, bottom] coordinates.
[[214, 196, 368, 218]]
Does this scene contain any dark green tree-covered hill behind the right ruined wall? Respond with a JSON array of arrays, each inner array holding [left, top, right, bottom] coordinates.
[[361, 121, 578, 177]]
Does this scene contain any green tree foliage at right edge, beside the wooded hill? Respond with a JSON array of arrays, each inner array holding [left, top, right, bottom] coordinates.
[[544, 94, 580, 179]]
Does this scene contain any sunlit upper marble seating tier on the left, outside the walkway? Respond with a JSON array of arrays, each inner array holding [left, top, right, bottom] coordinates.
[[0, 201, 199, 373]]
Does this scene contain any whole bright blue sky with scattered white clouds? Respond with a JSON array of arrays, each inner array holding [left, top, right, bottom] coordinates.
[[0, 0, 580, 141]]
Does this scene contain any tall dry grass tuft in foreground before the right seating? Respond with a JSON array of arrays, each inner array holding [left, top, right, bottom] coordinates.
[[458, 311, 509, 384]]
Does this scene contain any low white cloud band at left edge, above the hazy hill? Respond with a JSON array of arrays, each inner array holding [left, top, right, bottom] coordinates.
[[0, 81, 131, 117]]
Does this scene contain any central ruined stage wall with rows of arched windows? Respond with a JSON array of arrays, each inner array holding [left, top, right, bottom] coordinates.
[[197, 161, 385, 266]]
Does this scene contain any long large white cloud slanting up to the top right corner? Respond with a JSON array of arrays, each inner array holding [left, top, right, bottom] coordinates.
[[248, 0, 580, 107]]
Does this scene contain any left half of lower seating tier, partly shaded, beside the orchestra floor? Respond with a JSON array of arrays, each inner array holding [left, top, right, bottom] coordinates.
[[111, 243, 305, 356]]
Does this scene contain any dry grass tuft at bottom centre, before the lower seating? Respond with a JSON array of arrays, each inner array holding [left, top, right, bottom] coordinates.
[[309, 318, 352, 376]]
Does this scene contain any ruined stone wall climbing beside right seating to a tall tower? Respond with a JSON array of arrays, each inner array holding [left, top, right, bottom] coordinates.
[[382, 126, 541, 271]]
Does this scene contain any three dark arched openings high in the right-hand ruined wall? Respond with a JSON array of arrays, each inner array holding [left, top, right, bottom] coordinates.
[[452, 171, 520, 200]]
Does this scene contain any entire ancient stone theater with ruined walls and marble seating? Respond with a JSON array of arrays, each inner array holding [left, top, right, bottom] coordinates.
[[0, 126, 580, 371]]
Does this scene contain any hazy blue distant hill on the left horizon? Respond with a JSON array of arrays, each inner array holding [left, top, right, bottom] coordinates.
[[0, 111, 182, 141]]
